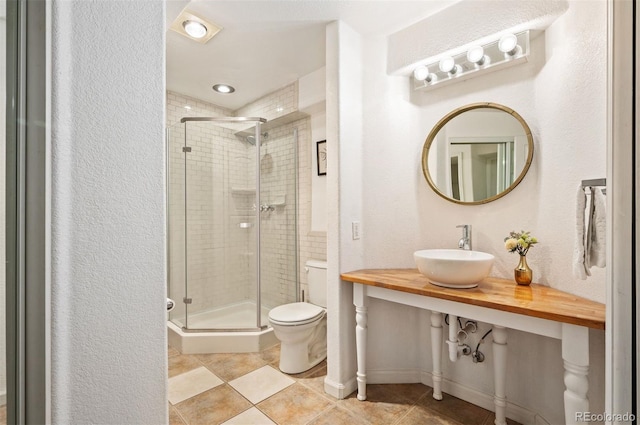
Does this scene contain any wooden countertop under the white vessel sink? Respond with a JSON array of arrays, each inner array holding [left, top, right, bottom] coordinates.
[[340, 269, 605, 329]]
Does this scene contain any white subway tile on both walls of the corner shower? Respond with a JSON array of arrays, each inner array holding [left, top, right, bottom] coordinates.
[[167, 84, 326, 322]]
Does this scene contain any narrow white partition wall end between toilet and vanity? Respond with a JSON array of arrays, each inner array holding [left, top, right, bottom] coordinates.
[[325, 22, 364, 398]]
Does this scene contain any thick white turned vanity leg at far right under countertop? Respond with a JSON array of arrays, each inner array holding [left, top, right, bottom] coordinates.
[[562, 323, 589, 424]]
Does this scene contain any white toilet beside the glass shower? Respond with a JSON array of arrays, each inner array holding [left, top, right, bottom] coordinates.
[[269, 260, 327, 374]]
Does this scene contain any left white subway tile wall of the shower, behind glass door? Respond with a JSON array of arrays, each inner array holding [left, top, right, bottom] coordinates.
[[167, 93, 255, 324]]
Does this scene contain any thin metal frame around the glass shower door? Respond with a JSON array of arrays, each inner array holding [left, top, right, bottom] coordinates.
[[180, 117, 268, 333]]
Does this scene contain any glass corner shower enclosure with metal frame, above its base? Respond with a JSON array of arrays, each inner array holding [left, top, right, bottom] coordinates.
[[167, 117, 299, 338]]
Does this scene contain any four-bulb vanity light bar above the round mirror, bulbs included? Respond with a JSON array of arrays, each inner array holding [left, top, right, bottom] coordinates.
[[411, 31, 530, 90]]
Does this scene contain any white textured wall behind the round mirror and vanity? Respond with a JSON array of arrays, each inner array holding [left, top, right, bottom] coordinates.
[[336, 1, 607, 423]]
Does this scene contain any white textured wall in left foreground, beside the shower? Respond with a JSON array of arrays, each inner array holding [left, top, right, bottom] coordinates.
[[47, 0, 168, 424]]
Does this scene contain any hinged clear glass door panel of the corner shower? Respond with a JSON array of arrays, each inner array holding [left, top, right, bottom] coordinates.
[[182, 118, 260, 331]]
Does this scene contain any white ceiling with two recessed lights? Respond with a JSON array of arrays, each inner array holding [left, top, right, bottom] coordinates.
[[166, 0, 456, 110]]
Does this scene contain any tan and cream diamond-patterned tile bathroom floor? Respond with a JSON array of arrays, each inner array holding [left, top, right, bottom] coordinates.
[[169, 346, 517, 425]]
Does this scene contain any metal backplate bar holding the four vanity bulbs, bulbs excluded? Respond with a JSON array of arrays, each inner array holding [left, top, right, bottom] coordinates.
[[410, 30, 530, 91]]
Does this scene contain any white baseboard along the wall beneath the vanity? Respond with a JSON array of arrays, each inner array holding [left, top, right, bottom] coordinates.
[[356, 369, 546, 425]]
